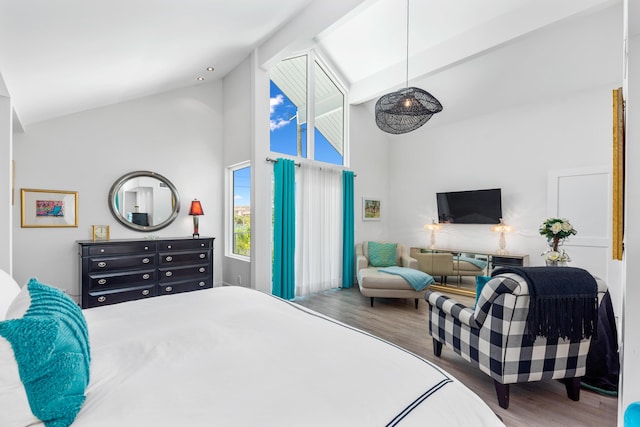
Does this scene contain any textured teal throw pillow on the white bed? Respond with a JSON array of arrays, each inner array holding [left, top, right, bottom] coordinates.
[[0, 279, 91, 427]]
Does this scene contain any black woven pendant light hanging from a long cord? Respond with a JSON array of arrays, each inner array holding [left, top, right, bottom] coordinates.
[[375, 0, 442, 134]]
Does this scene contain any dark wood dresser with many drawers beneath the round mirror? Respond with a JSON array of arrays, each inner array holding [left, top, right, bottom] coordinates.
[[77, 237, 214, 308]]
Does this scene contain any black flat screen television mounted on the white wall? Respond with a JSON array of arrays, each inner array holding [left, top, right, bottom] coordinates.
[[436, 188, 502, 224]]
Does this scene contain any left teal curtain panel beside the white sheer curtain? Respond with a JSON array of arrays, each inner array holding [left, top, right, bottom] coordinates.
[[271, 158, 296, 300]]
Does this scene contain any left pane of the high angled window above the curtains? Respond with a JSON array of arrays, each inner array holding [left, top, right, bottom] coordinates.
[[270, 55, 307, 158]]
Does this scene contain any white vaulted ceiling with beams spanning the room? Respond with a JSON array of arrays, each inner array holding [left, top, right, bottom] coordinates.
[[0, 0, 622, 127]]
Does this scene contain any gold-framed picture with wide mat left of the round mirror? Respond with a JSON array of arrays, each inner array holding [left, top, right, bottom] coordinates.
[[20, 188, 78, 228]]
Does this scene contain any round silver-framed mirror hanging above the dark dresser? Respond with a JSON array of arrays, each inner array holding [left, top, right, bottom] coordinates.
[[109, 171, 180, 231]]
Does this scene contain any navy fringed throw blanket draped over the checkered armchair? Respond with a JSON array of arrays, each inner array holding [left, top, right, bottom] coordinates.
[[491, 267, 598, 341]]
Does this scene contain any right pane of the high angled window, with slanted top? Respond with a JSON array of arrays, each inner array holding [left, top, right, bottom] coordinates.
[[313, 62, 344, 165]]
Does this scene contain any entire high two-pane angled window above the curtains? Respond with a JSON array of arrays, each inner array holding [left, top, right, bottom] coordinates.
[[270, 51, 347, 166]]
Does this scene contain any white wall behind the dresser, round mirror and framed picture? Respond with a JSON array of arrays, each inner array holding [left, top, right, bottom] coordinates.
[[13, 82, 223, 297]]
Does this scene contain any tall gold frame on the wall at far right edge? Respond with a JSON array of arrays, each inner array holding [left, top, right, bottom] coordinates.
[[611, 88, 625, 261]]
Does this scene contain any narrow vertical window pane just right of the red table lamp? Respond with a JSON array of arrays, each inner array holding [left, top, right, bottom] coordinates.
[[232, 167, 251, 256]]
